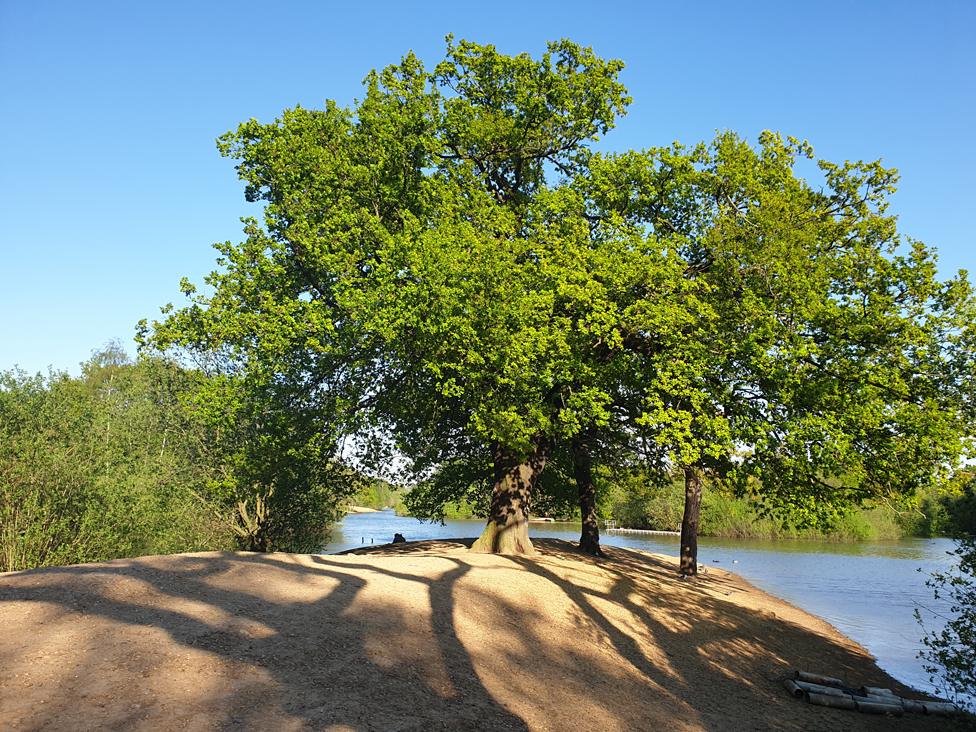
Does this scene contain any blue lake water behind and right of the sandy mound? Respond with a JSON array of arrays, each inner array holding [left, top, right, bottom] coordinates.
[[326, 511, 954, 691]]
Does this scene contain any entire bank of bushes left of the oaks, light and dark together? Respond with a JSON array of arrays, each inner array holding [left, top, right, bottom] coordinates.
[[0, 347, 354, 571]]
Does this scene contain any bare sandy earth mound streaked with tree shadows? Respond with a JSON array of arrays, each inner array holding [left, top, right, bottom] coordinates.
[[0, 540, 951, 731]]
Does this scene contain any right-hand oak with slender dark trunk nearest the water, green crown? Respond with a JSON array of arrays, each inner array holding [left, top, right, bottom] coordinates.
[[586, 133, 974, 574]]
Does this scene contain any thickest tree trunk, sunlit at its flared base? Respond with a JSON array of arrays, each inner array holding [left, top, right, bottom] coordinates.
[[471, 440, 547, 554]]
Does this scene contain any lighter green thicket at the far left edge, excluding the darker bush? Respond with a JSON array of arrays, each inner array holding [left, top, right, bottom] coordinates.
[[0, 349, 229, 571]]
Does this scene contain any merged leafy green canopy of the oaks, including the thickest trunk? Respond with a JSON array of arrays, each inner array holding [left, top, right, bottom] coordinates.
[[143, 37, 974, 552]]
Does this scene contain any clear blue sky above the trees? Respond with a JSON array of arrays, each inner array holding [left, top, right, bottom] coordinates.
[[0, 0, 976, 372]]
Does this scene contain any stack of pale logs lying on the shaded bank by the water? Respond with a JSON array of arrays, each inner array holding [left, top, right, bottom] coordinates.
[[783, 671, 960, 717]]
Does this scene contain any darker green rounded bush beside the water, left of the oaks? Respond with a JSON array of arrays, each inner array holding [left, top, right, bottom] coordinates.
[[187, 373, 361, 552]]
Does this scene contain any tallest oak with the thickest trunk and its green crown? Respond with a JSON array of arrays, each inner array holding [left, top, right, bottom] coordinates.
[[147, 39, 629, 552]]
